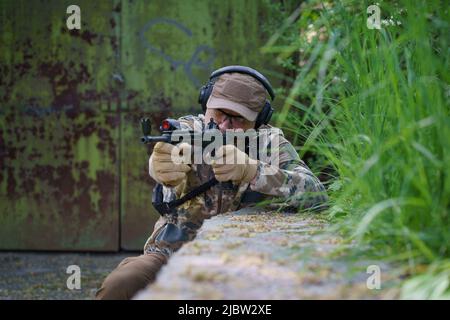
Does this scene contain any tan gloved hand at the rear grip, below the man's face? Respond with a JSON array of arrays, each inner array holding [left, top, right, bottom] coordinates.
[[211, 145, 258, 183]]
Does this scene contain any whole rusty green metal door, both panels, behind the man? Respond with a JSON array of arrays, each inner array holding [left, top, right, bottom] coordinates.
[[0, 0, 273, 251]]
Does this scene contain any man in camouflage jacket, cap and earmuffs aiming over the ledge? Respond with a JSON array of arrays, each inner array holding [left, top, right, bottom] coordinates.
[[97, 66, 327, 299]]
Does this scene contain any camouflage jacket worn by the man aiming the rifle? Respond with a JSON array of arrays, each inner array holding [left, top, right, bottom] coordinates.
[[144, 114, 327, 257]]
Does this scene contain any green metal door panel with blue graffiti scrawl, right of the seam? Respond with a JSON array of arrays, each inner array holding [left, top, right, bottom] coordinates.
[[121, 0, 274, 249]]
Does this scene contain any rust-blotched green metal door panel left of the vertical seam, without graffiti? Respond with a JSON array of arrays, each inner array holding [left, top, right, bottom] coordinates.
[[0, 1, 120, 250]]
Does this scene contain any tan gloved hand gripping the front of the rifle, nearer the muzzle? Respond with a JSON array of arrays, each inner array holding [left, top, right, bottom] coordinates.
[[148, 142, 191, 187]]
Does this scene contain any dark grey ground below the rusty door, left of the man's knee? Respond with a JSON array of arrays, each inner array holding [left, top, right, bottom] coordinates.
[[0, 252, 130, 300]]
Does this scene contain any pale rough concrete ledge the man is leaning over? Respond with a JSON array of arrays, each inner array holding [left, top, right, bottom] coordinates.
[[135, 211, 398, 299]]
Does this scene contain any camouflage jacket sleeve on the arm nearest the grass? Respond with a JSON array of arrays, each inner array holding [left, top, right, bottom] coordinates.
[[250, 131, 328, 210]]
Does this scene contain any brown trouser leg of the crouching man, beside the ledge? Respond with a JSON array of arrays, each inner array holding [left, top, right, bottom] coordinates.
[[95, 252, 167, 300]]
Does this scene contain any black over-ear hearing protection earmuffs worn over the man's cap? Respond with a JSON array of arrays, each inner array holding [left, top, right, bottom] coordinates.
[[198, 66, 275, 129]]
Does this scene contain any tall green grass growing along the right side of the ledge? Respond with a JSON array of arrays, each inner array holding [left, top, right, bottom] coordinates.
[[262, 1, 450, 298]]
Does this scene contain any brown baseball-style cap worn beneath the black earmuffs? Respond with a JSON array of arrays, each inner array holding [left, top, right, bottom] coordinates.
[[206, 72, 266, 121]]
